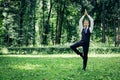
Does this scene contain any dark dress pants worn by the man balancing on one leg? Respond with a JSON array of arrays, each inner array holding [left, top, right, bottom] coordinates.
[[70, 41, 89, 70]]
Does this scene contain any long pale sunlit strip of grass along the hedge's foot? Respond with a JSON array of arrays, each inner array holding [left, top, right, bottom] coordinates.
[[0, 54, 120, 58]]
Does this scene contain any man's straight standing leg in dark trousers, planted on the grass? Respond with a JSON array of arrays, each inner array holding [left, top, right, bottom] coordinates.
[[83, 45, 89, 70]]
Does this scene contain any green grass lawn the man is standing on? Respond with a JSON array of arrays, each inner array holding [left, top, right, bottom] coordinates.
[[0, 56, 120, 80]]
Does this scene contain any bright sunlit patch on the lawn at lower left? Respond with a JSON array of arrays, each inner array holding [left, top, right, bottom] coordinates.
[[13, 64, 39, 70]]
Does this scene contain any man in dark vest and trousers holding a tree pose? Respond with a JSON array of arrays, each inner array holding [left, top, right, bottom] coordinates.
[[70, 10, 94, 71]]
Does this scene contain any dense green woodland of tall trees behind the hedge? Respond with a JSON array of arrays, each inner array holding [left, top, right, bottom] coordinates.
[[0, 0, 120, 47]]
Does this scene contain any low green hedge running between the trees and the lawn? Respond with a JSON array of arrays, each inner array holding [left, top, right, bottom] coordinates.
[[0, 46, 120, 54]]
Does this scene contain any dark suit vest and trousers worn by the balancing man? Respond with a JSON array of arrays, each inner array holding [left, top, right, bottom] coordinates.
[[70, 28, 91, 70]]
